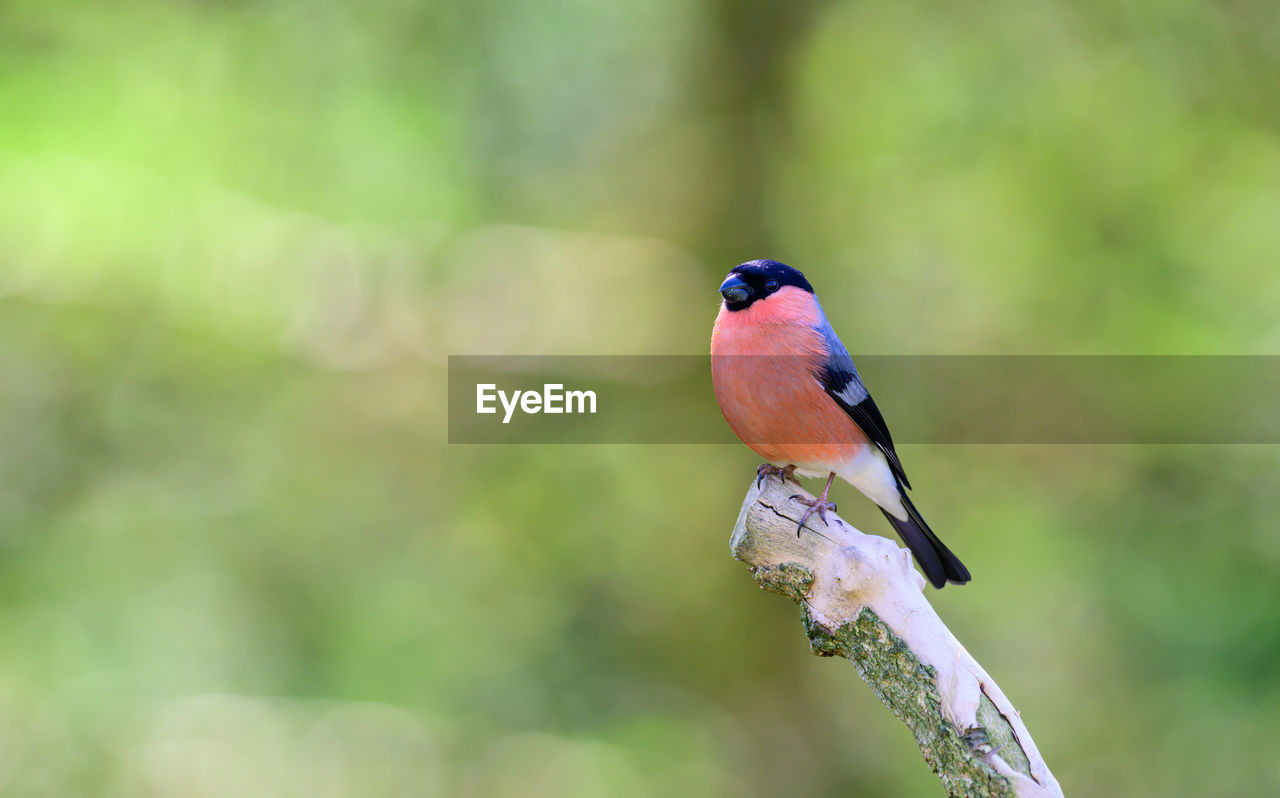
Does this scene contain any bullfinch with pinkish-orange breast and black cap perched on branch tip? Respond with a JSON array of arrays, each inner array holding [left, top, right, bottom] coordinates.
[[712, 260, 969, 588]]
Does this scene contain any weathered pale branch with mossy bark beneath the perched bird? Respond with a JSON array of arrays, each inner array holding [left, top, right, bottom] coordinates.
[[731, 476, 1062, 798]]
